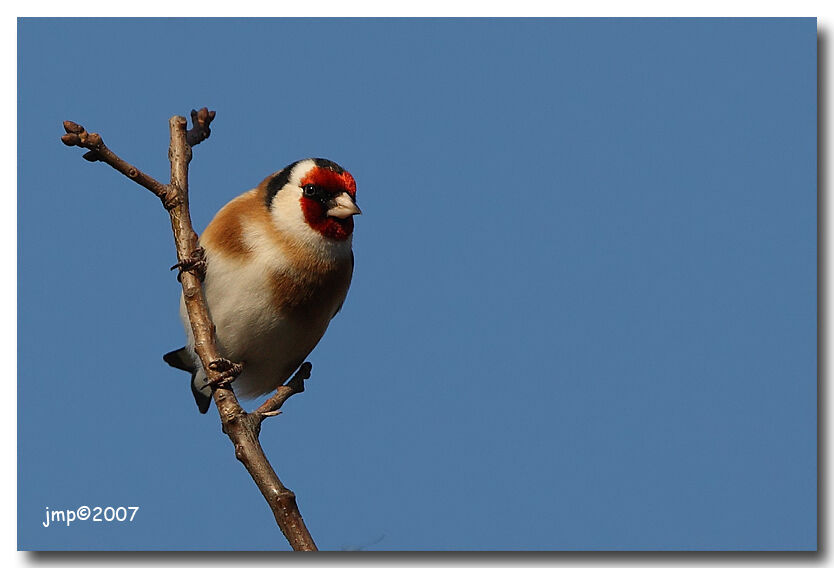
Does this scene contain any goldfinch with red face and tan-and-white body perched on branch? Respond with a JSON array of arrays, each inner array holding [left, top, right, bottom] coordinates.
[[163, 158, 362, 414]]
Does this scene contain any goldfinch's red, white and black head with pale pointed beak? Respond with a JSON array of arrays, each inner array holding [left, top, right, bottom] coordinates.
[[265, 158, 362, 241]]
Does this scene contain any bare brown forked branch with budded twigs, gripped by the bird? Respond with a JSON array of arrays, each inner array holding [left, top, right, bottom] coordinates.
[[61, 108, 316, 550]]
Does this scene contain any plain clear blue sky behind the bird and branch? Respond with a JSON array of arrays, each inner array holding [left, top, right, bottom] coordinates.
[[18, 19, 817, 550]]
